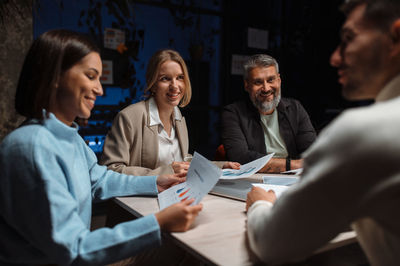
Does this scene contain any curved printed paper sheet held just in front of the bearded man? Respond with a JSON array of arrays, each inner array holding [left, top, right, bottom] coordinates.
[[220, 153, 274, 179]]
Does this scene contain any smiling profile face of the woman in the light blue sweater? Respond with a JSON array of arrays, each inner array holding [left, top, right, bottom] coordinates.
[[49, 52, 103, 126]]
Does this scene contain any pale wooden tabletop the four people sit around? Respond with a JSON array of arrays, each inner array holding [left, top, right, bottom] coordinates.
[[114, 189, 356, 266]]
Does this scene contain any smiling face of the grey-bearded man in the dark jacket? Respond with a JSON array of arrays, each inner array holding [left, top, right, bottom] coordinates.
[[244, 66, 281, 114]]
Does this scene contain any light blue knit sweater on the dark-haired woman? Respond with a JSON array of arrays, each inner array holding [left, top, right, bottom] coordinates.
[[0, 111, 161, 265]]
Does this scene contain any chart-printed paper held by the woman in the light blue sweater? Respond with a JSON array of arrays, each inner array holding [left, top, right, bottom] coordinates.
[[158, 152, 222, 210]]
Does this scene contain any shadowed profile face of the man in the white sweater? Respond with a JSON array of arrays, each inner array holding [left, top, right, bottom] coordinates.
[[330, 5, 392, 100]]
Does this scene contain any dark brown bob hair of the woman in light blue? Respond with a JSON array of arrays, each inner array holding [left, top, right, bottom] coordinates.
[[15, 30, 99, 119]]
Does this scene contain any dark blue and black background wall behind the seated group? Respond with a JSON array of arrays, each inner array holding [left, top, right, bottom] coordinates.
[[23, 0, 368, 159]]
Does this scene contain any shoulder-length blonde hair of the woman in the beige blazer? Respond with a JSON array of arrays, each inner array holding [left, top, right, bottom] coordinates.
[[144, 49, 192, 107]]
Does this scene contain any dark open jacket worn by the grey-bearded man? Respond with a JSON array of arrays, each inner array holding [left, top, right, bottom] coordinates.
[[221, 98, 316, 164]]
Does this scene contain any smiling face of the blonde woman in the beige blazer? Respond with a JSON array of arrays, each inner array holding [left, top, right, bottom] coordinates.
[[151, 60, 185, 110]]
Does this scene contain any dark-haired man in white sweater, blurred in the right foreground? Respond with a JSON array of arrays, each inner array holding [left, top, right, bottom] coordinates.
[[247, 0, 400, 266]]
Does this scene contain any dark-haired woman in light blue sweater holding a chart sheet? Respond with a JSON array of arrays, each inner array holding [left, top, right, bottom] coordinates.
[[0, 30, 202, 265]]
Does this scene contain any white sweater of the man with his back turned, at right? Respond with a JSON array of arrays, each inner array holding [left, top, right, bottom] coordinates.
[[247, 76, 400, 266]]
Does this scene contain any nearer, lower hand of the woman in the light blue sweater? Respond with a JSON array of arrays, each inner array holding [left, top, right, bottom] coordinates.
[[155, 199, 203, 232]]
